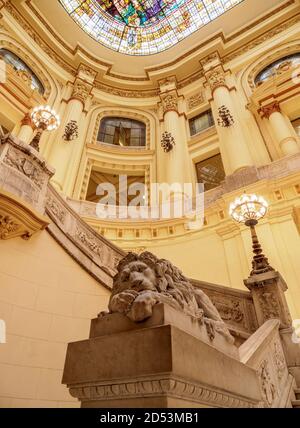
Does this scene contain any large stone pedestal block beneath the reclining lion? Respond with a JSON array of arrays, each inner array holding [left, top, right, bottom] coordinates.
[[63, 304, 261, 408]]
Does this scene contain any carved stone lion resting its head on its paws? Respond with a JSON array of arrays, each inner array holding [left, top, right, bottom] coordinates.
[[105, 252, 234, 343]]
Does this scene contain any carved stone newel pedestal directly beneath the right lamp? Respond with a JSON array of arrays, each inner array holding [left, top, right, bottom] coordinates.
[[244, 271, 292, 328]]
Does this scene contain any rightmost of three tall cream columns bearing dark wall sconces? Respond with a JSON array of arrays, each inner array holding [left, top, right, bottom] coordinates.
[[202, 61, 254, 175]]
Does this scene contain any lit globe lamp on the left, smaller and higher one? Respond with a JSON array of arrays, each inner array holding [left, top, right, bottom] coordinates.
[[30, 106, 60, 151]]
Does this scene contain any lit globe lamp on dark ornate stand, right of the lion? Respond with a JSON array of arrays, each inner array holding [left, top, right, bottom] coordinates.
[[229, 194, 274, 275]]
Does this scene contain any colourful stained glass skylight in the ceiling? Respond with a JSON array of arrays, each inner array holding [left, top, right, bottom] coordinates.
[[59, 0, 243, 55]]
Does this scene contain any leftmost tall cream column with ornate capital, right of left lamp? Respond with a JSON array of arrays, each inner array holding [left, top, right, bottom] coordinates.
[[49, 68, 96, 196]]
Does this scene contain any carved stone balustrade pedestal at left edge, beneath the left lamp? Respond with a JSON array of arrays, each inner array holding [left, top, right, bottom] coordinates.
[[0, 135, 54, 239]]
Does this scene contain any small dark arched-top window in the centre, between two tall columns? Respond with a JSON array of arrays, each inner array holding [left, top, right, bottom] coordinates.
[[98, 117, 146, 147]]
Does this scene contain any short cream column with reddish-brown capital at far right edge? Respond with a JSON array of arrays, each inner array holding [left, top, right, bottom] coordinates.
[[259, 101, 299, 156]]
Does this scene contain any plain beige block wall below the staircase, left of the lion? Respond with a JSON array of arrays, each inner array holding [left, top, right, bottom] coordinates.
[[0, 232, 109, 407]]
